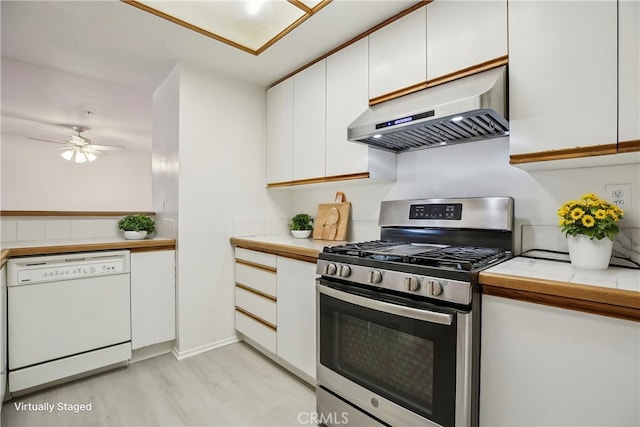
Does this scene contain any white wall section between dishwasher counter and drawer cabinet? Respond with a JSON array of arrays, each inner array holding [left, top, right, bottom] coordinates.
[[165, 63, 289, 356]]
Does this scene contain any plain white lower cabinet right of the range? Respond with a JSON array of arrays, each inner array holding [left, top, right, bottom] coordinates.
[[480, 295, 640, 427]]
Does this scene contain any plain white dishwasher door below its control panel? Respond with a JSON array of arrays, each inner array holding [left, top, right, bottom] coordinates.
[[8, 273, 131, 370]]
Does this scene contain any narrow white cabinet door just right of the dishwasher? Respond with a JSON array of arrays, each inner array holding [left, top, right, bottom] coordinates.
[[131, 251, 176, 349]]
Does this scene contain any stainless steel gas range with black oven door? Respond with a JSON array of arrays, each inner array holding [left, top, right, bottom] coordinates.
[[316, 197, 513, 426]]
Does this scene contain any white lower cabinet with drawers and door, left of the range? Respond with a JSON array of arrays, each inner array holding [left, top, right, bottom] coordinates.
[[235, 248, 316, 383]]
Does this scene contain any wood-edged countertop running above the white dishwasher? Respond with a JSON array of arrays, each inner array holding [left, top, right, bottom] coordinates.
[[0, 237, 176, 266]]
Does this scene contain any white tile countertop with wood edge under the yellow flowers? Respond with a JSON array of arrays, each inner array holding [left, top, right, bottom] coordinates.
[[480, 257, 640, 321]]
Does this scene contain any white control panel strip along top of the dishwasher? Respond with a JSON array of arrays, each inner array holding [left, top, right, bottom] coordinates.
[[7, 251, 129, 286]]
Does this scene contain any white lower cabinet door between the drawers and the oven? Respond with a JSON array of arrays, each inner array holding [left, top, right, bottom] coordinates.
[[277, 257, 316, 378]]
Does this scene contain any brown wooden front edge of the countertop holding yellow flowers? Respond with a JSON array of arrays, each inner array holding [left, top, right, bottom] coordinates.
[[480, 273, 640, 322]]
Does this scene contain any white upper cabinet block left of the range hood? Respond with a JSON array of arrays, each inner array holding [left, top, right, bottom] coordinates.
[[267, 38, 396, 185]]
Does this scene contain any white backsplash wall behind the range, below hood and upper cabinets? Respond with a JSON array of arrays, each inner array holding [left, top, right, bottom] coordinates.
[[291, 138, 640, 249]]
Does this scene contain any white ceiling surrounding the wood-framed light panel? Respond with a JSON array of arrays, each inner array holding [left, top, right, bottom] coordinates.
[[0, 0, 417, 150]]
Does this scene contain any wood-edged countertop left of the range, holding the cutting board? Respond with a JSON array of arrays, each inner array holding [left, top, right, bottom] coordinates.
[[231, 234, 347, 263]]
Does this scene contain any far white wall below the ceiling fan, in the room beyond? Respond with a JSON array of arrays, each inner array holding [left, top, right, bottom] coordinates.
[[1, 134, 151, 211]]
